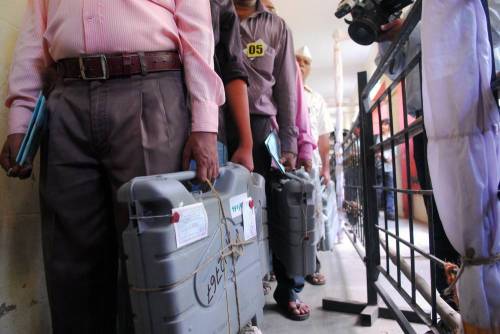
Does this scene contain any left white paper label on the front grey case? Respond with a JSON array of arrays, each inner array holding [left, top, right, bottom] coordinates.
[[172, 203, 208, 248]]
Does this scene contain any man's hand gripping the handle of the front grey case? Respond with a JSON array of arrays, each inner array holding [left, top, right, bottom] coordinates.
[[182, 132, 219, 181]]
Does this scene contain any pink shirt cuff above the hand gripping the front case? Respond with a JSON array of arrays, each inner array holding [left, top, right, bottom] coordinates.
[[191, 101, 219, 133]]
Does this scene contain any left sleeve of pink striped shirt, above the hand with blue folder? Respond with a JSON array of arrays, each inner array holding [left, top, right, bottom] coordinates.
[[5, 0, 53, 134]]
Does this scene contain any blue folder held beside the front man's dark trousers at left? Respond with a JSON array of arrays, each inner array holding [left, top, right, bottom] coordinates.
[[16, 92, 47, 166]]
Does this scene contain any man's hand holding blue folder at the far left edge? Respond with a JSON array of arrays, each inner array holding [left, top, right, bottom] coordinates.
[[0, 133, 33, 179]]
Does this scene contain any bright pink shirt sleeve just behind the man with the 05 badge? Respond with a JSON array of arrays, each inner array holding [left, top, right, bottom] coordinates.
[[295, 63, 316, 161]]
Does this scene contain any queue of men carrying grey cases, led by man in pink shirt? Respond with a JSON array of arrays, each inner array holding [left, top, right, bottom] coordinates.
[[0, 0, 340, 333]]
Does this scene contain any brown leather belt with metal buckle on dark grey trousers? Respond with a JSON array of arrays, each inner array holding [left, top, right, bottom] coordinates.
[[57, 51, 182, 80]]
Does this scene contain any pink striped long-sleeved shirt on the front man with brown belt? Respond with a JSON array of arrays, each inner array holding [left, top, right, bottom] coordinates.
[[6, 0, 224, 134]]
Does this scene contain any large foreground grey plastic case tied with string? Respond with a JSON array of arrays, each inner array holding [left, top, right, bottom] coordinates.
[[118, 164, 264, 334]]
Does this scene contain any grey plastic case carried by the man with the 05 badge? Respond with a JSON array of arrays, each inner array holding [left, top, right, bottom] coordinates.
[[268, 171, 319, 276]]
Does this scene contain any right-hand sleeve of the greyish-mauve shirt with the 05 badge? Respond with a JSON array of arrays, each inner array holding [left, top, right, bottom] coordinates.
[[273, 21, 298, 154]]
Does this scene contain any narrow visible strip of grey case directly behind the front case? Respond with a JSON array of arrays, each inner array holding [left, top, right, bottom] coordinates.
[[248, 173, 271, 277]]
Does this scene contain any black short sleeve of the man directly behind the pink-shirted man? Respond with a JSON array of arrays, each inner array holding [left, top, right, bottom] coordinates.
[[215, 0, 248, 84]]
